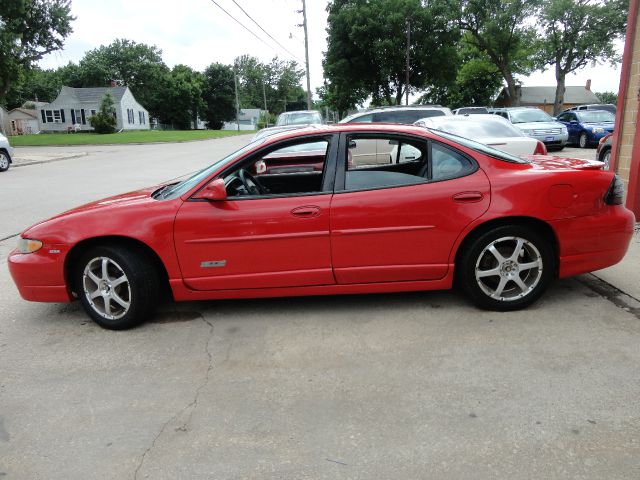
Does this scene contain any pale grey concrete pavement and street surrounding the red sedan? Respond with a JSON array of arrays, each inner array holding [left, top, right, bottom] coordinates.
[[0, 137, 640, 480]]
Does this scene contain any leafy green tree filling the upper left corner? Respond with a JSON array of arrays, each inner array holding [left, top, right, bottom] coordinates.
[[0, 0, 74, 104]]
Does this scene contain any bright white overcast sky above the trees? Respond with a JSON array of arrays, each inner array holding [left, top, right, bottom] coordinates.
[[40, 0, 622, 104]]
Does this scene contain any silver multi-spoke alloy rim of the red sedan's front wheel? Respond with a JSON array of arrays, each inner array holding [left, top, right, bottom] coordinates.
[[82, 257, 131, 320]]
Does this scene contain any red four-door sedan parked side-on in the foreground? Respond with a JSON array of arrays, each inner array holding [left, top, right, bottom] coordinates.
[[9, 124, 634, 329]]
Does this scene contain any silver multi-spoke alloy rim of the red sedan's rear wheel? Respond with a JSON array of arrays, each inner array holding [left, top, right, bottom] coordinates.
[[475, 237, 543, 302]]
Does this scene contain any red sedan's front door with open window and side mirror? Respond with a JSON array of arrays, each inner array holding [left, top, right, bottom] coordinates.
[[174, 136, 337, 290]]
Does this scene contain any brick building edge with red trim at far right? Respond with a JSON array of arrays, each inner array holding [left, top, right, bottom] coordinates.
[[611, 0, 640, 220]]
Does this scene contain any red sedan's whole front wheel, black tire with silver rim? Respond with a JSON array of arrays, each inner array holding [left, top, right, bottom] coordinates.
[[73, 246, 161, 330]]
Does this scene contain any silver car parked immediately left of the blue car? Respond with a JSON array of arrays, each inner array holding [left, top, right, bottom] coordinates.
[[491, 107, 569, 150]]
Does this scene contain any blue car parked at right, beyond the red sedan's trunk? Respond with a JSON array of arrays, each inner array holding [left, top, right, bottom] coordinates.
[[558, 110, 615, 148]]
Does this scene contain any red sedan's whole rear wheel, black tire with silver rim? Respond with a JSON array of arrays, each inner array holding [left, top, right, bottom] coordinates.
[[456, 225, 556, 311]]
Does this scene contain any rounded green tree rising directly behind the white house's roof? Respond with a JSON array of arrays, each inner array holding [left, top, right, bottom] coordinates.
[[78, 39, 169, 117]]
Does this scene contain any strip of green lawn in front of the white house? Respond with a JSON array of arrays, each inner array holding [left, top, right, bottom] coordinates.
[[9, 130, 255, 147]]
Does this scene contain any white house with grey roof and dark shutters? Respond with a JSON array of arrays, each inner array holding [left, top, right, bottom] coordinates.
[[37, 87, 149, 132]]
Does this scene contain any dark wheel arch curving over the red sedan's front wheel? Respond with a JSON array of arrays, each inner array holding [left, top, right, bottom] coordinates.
[[64, 235, 173, 298]]
